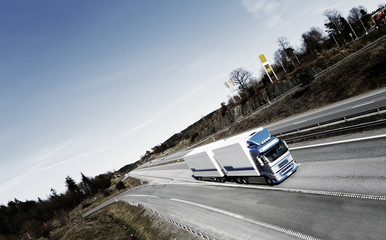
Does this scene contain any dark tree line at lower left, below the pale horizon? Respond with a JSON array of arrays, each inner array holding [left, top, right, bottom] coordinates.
[[0, 172, 116, 239]]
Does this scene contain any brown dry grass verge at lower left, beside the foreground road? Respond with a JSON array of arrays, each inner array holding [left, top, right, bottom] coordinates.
[[40, 177, 198, 240]]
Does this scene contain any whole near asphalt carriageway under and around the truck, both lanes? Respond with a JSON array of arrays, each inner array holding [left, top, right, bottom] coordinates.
[[128, 136, 386, 239]]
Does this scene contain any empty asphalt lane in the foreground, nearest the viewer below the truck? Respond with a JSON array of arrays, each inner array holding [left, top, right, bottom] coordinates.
[[118, 181, 386, 239]]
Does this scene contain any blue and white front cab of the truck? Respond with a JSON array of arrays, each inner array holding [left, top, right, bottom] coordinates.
[[247, 128, 298, 185]]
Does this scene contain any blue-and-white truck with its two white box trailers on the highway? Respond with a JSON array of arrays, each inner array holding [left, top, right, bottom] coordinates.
[[183, 128, 298, 185]]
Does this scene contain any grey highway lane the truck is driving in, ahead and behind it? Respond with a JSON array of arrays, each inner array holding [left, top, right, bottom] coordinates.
[[131, 133, 386, 196]]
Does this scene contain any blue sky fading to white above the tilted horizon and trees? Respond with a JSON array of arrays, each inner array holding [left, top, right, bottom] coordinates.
[[0, 0, 382, 204]]
